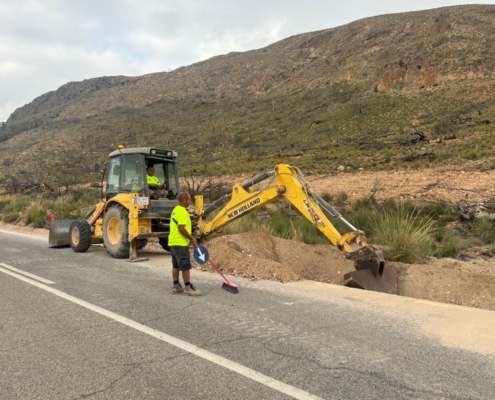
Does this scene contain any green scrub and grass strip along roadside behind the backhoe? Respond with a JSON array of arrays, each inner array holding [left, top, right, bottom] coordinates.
[[0, 189, 488, 263]]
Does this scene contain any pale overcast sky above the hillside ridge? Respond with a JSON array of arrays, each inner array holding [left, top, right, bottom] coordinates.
[[0, 0, 494, 121]]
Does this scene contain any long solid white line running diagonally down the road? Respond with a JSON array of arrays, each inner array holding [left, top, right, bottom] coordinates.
[[0, 264, 323, 400]]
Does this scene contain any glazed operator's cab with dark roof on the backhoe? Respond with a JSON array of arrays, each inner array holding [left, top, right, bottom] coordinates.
[[105, 147, 179, 212]]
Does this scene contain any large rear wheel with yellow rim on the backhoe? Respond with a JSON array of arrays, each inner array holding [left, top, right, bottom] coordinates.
[[103, 204, 129, 258]]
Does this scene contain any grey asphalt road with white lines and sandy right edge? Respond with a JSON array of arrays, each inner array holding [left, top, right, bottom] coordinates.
[[0, 231, 495, 400]]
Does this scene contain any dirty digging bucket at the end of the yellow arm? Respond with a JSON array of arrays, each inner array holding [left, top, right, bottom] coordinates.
[[344, 246, 397, 294]]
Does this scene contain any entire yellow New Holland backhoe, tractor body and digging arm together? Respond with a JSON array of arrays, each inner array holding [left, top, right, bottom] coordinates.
[[48, 146, 397, 293]]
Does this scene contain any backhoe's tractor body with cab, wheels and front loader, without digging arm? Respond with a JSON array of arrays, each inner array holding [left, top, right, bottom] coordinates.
[[48, 146, 183, 261]]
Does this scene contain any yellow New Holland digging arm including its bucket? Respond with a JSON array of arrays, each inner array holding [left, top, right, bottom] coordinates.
[[193, 164, 397, 294]]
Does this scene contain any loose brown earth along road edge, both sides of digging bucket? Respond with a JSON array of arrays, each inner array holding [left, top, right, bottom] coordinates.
[[196, 232, 495, 310]]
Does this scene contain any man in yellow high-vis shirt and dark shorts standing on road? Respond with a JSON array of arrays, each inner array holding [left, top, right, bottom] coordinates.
[[168, 192, 201, 296]]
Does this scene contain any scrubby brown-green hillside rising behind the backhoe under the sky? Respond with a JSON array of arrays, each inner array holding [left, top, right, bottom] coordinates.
[[0, 5, 495, 184]]
